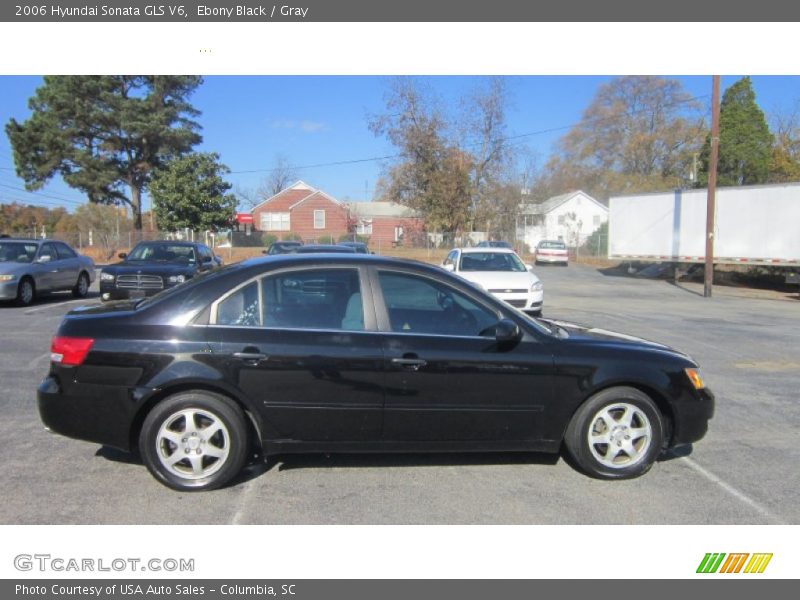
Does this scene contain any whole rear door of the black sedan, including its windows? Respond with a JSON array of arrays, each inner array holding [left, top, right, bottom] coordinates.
[[203, 266, 384, 441]]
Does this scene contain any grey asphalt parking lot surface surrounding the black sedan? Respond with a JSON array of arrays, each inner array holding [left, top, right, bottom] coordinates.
[[0, 265, 800, 524]]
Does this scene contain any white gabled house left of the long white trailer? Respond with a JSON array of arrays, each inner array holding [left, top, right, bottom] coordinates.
[[517, 190, 608, 250]]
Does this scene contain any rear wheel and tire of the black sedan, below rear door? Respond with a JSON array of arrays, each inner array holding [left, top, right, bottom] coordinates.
[[139, 391, 248, 492]]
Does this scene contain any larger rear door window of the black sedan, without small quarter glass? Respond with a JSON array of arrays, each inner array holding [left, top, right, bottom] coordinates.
[[262, 269, 364, 331]]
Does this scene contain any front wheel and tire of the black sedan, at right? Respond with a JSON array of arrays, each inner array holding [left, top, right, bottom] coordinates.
[[564, 387, 664, 479]]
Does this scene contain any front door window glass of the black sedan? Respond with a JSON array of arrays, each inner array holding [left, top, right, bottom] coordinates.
[[378, 271, 498, 336]]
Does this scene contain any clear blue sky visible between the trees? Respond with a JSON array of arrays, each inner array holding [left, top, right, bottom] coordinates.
[[0, 75, 800, 210]]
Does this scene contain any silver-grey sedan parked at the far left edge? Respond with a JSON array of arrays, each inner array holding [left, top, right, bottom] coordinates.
[[0, 237, 94, 306]]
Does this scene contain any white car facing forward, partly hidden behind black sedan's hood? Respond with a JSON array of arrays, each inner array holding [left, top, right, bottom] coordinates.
[[442, 248, 544, 315]]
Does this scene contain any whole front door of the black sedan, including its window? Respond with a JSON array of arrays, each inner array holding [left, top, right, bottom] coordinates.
[[376, 270, 553, 442]]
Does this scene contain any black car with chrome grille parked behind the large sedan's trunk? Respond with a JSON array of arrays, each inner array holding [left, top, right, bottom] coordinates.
[[100, 241, 222, 301]]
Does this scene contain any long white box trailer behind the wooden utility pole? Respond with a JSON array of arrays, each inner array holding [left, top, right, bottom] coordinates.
[[608, 183, 800, 267]]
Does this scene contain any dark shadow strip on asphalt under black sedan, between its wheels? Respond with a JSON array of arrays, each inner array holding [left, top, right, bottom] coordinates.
[[266, 452, 560, 471]]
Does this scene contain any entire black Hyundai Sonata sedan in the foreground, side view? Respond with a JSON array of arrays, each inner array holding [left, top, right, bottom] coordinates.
[[38, 254, 714, 490]]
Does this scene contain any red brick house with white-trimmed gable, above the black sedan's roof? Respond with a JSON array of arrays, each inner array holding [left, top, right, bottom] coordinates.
[[253, 181, 350, 242]]
